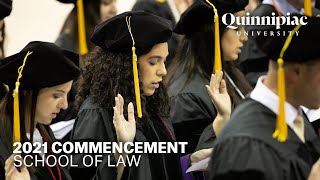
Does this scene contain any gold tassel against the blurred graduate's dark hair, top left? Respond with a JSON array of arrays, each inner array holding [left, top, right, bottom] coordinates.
[[77, 0, 88, 55]]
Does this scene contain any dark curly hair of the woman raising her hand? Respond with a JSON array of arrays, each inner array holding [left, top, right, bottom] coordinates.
[[77, 47, 169, 126]]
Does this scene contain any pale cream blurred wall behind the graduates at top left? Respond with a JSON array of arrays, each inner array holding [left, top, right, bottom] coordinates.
[[4, 0, 136, 56]]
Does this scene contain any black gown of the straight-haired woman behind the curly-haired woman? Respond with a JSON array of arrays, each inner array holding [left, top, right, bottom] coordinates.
[[168, 74, 217, 154]]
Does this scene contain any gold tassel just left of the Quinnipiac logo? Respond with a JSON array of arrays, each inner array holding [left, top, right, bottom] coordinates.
[[206, 0, 222, 74]]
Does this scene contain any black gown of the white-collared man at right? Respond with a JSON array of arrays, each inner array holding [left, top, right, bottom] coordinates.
[[209, 98, 320, 180]]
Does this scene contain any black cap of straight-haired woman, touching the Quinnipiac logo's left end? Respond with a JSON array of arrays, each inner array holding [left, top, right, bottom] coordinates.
[[174, 0, 248, 34]]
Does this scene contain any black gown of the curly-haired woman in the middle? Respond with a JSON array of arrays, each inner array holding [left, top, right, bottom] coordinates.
[[70, 98, 182, 180]]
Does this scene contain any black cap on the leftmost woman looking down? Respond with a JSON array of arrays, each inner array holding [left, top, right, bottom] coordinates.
[[0, 41, 80, 91]]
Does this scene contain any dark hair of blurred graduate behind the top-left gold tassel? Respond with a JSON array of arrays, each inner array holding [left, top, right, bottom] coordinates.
[[61, 0, 101, 51]]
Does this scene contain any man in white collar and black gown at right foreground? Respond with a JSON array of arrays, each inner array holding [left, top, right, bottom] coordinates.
[[209, 16, 320, 180]]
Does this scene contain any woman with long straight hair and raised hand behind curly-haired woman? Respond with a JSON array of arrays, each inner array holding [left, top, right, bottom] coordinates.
[[165, 0, 251, 154]]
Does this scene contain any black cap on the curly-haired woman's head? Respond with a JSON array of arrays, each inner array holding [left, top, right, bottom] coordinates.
[[91, 11, 172, 53]]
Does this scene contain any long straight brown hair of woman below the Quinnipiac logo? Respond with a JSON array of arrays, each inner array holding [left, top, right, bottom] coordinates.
[[164, 24, 252, 105]]
